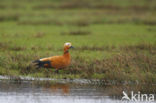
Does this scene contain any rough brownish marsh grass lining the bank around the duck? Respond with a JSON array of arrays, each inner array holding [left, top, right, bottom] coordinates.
[[0, 44, 156, 85]]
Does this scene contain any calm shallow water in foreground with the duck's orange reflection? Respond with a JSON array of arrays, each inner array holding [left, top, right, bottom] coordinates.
[[0, 77, 154, 103]]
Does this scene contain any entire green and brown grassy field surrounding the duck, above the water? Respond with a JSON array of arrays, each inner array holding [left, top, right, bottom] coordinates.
[[0, 0, 156, 83]]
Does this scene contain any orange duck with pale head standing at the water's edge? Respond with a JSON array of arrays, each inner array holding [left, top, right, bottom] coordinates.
[[33, 42, 74, 70]]
